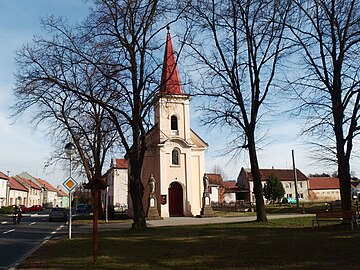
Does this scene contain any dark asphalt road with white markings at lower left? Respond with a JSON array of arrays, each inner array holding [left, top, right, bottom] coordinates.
[[0, 213, 68, 269]]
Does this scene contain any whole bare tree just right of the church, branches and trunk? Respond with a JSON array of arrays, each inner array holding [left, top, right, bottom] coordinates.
[[183, 0, 290, 221]]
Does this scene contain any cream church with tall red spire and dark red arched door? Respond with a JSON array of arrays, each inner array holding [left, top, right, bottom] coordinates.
[[142, 32, 208, 217]]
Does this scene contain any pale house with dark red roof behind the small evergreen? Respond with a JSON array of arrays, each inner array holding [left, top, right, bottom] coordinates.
[[237, 168, 308, 202]]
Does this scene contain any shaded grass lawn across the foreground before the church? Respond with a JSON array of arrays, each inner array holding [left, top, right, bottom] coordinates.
[[17, 217, 360, 270]]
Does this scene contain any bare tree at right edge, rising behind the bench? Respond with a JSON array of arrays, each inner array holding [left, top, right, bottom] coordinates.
[[289, 0, 360, 209]]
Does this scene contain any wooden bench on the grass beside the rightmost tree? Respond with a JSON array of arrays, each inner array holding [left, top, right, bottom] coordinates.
[[312, 210, 359, 230]]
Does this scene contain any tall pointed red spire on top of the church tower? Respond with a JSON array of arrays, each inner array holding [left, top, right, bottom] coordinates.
[[160, 27, 183, 95]]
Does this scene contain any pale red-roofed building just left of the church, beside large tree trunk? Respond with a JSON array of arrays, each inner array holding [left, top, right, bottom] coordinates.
[[102, 158, 128, 207]]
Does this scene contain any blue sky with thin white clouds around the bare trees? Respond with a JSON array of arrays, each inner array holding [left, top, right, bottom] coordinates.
[[0, 0, 344, 186]]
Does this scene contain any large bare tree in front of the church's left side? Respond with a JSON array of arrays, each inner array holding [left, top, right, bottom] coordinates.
[[12, 0, 184, 228]]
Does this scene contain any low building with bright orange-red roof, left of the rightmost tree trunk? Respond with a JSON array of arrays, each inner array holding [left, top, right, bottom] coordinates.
[[308, 177, 340, 202]]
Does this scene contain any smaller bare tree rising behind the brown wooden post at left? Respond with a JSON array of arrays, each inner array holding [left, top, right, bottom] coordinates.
[[12, 43, 117, 180]]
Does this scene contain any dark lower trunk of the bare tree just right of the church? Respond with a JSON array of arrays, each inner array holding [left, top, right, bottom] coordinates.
[[248, 133, 267, 222]]
